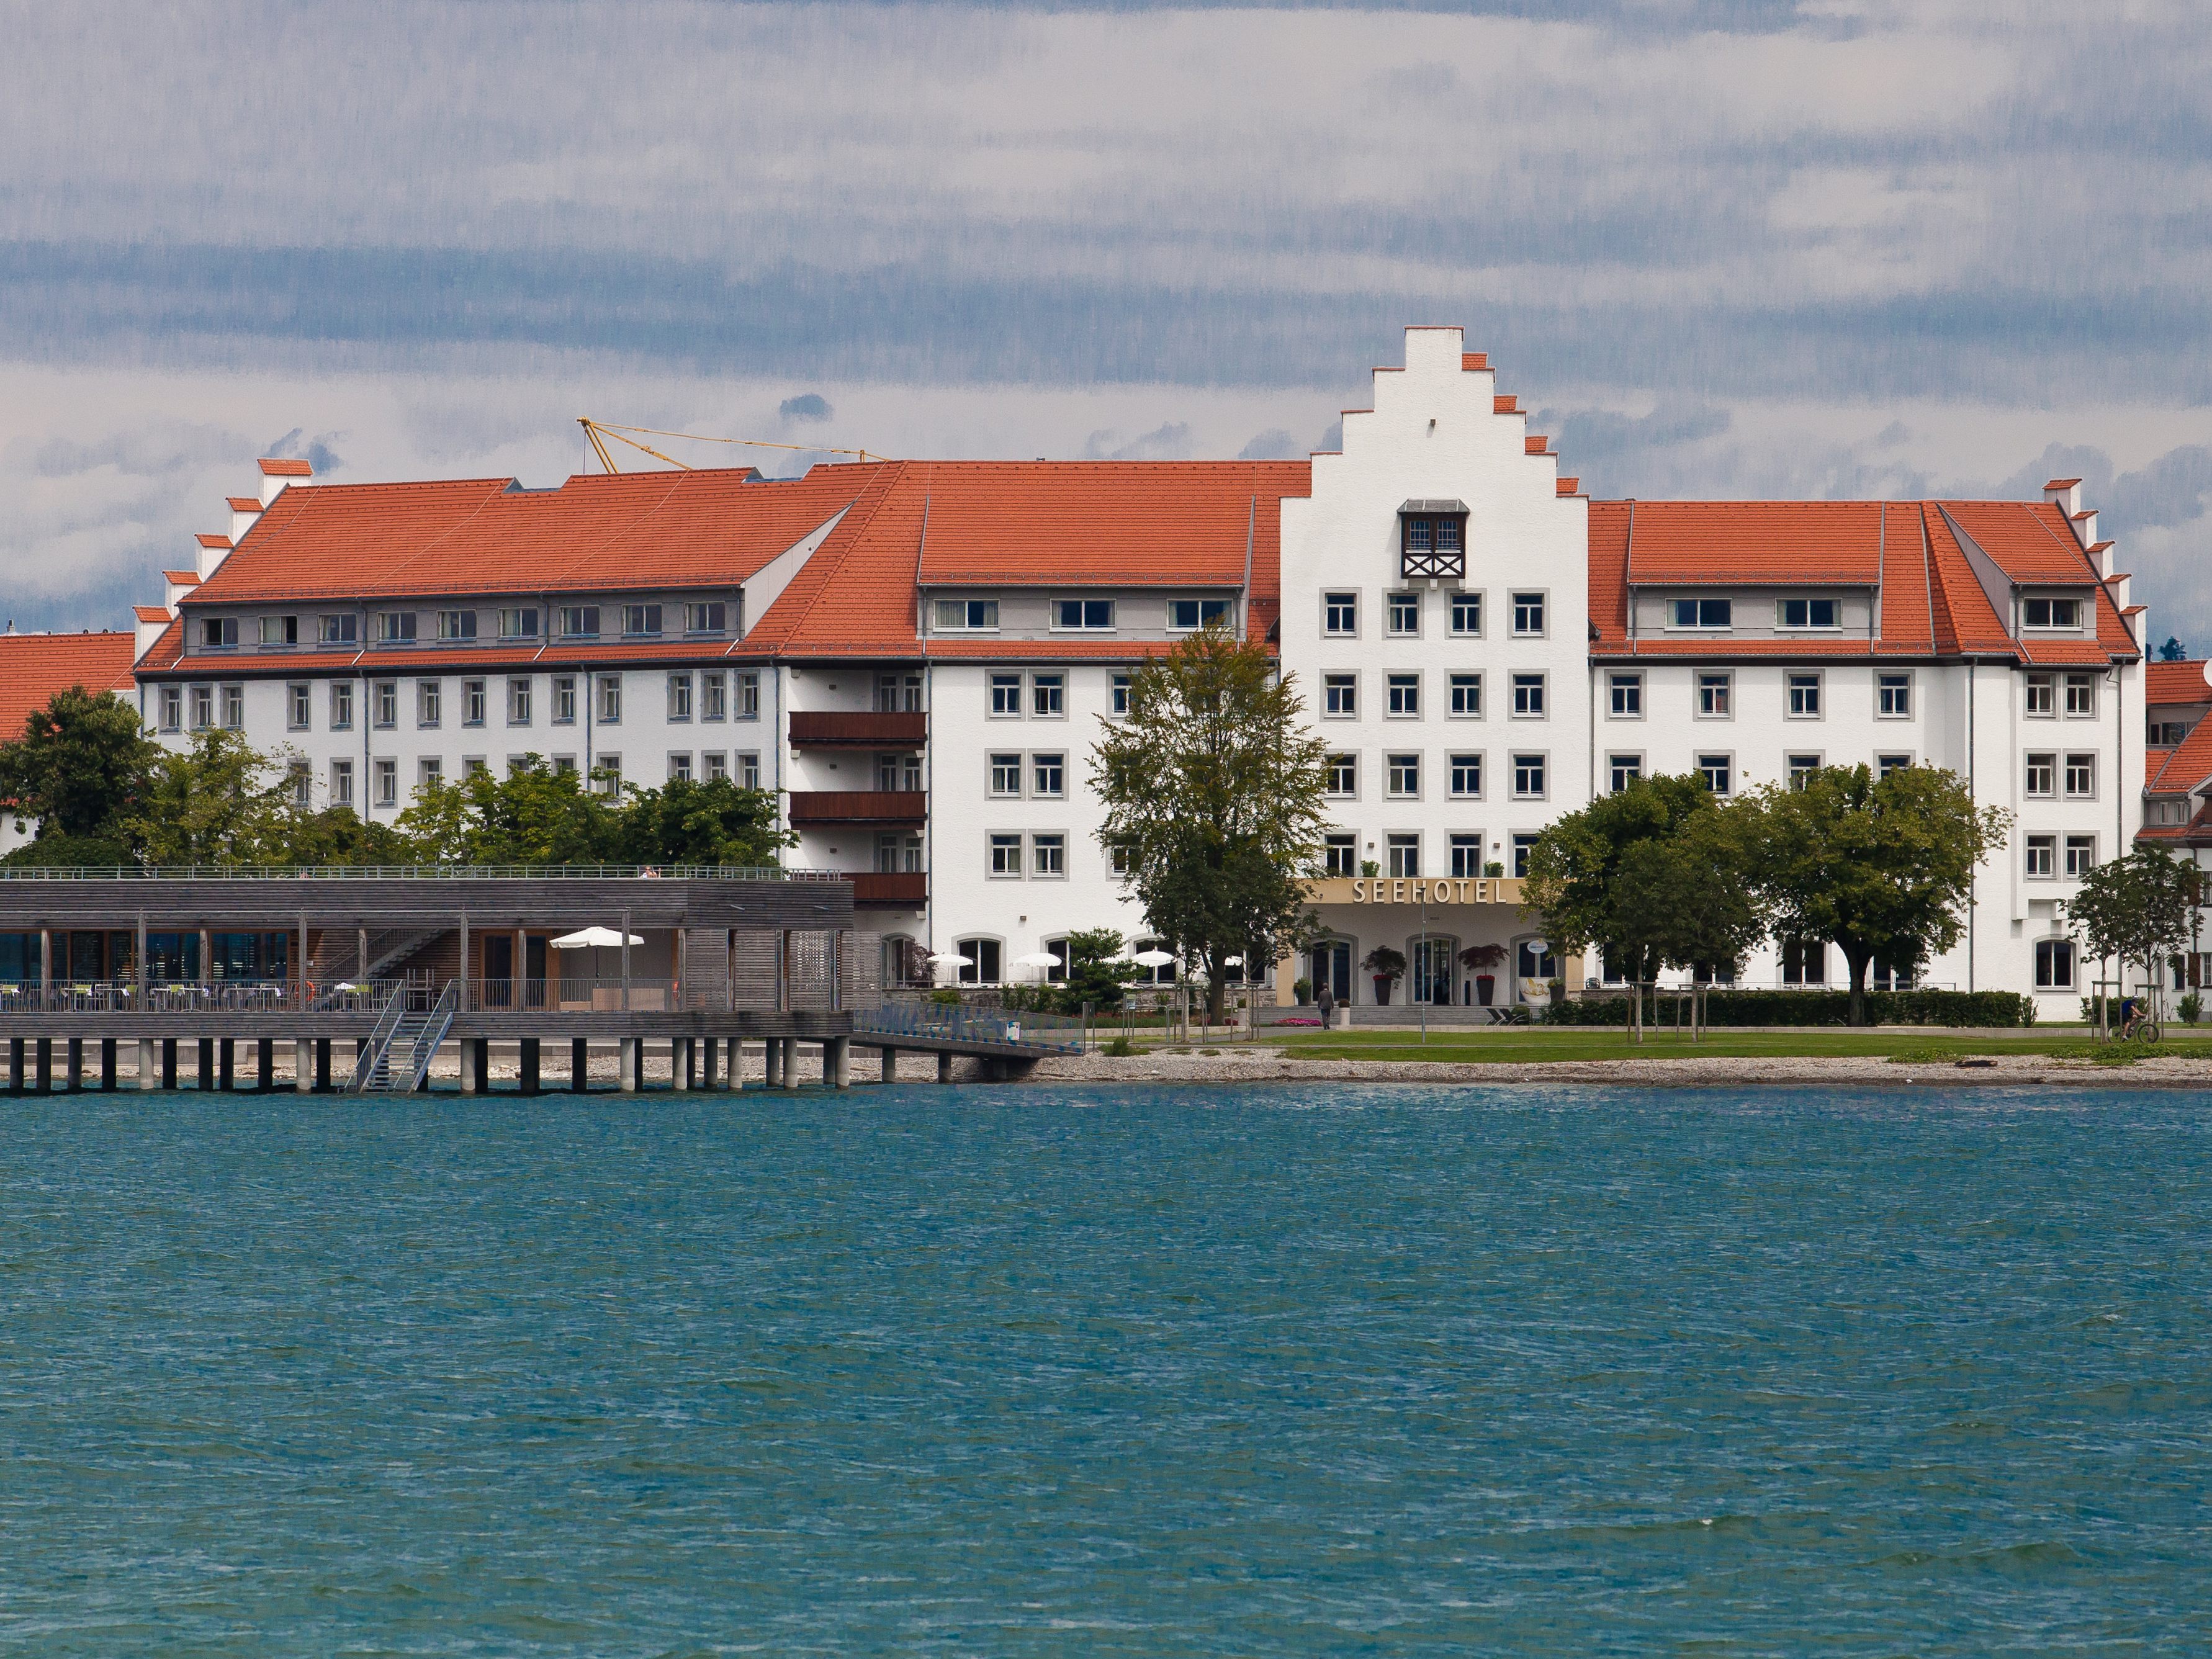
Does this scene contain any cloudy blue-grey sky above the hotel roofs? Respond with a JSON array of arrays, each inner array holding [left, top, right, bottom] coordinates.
[[0, 0, 2212, 650]]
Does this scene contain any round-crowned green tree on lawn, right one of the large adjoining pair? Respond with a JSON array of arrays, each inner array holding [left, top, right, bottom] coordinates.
[[1754, 765, 2013, 1024]]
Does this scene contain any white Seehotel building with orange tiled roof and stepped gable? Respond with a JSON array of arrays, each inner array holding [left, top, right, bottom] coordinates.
[[117, 327, 2141, 1015]]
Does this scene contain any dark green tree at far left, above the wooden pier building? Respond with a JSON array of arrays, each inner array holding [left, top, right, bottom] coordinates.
[[0, 686, 161, 863]]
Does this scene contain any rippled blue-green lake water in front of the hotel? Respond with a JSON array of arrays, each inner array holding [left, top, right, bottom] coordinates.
[[0, 1086, 2212, 1655]]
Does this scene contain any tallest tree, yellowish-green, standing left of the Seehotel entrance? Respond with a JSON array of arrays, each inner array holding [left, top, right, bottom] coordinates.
[[1090, 628, 1327, 1017]]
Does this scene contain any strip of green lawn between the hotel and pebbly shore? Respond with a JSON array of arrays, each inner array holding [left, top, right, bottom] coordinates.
[[1139, 1027, 2212, 1064]]
